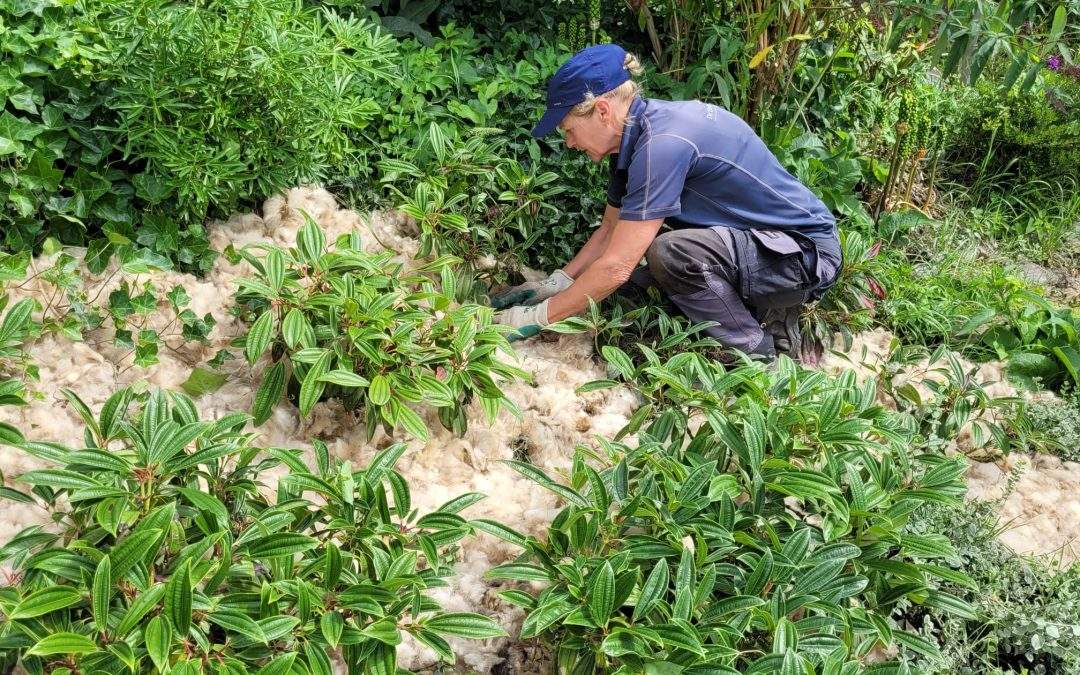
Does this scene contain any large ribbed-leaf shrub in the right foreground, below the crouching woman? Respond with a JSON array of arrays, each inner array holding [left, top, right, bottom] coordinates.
[[488, 348, 975, 673]]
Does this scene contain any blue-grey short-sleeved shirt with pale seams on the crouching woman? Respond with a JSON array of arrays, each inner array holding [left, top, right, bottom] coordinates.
[[608, 97, 840, 274]]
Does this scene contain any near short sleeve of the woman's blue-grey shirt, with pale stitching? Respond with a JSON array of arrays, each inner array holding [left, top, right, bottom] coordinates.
[[619, 136, 697, 220]]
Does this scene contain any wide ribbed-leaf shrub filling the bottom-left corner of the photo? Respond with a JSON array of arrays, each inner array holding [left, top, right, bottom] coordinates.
[[0, 389, 504, 674]]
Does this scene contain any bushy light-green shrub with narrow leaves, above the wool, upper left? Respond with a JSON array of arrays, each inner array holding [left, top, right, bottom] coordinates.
[[100, 0, 394, 222]]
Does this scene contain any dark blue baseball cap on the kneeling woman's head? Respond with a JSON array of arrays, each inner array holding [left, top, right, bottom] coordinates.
[[532, 44, 630, 138]]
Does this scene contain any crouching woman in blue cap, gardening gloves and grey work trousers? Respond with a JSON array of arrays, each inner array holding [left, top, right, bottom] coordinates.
[[491, 44, 841, 359]]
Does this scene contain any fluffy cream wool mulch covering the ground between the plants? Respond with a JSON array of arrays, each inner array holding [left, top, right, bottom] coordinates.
[[0, 188, 1080, 673]]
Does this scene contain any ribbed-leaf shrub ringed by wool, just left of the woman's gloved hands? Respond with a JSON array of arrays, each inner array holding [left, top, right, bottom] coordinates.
[[237, 218, 528, 438]]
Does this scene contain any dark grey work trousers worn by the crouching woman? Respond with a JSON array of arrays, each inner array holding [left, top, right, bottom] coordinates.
[[631, 227, 840, 354]]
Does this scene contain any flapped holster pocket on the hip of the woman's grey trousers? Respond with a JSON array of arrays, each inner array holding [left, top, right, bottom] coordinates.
[[737, 230, 813, 309]]
